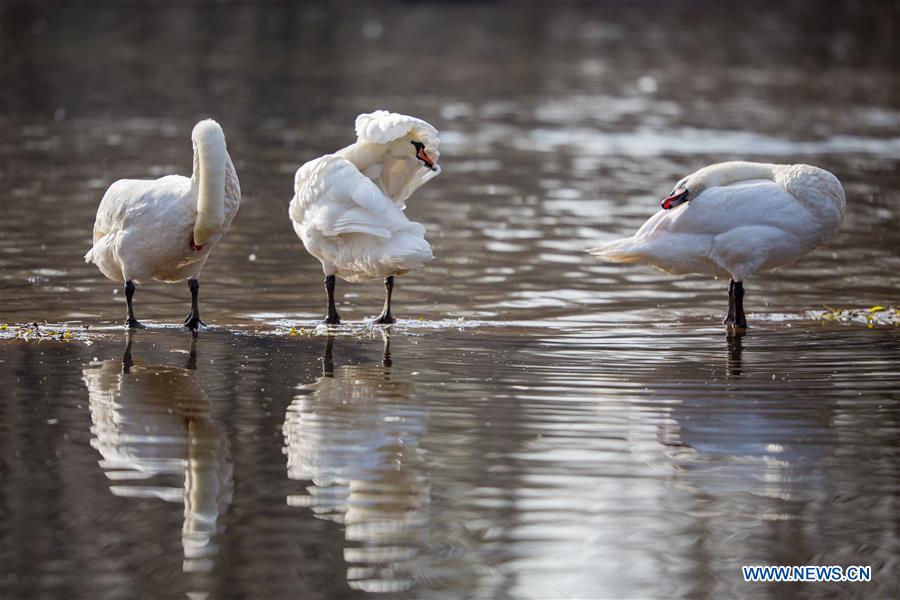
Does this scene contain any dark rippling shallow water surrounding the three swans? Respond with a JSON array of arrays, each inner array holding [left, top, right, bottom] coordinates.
[[0, 3, 900, 598]]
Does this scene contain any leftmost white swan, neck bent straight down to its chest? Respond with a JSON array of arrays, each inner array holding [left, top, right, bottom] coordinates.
[[84, 119, 241, 329]]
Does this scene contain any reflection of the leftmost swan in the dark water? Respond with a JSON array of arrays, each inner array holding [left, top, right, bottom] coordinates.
[[83, 334, 234, 572]]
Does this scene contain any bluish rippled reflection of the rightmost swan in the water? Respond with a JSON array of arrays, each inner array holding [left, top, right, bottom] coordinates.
[[657, 332, 835, 500]]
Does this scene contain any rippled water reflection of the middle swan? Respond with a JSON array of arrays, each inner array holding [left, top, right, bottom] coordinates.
[[284, 333, 430, 592]]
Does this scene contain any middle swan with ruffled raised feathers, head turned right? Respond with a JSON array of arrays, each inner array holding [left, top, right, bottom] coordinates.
[[289, 110, 441, 325]]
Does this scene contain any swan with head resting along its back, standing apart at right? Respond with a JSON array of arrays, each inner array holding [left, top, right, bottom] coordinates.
[[588, 161, 846, 329]]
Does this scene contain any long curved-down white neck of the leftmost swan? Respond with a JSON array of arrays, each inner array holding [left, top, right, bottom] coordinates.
[[191, 121, 228, 246]]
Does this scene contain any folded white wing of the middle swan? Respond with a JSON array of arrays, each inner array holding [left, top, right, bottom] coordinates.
[[291, 155, 409, 238]]
